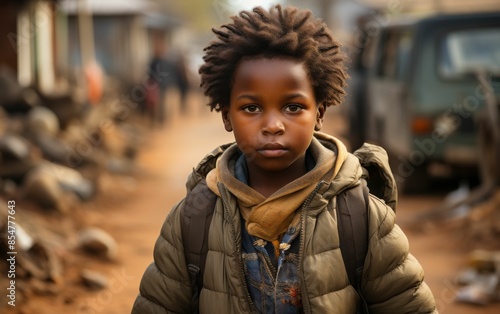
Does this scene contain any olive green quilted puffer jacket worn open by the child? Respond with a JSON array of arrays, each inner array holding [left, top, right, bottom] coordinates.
[[132, 135, 437, 314]]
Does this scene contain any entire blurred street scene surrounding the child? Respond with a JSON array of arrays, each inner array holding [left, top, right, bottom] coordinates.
[[0, 0, 500, 314]]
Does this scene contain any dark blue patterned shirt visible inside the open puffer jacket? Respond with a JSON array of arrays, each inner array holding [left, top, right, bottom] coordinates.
[[235, 154, 315, 314]]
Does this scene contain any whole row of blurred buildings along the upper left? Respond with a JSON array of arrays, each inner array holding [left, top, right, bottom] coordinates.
[[0, 0, 181, 99]]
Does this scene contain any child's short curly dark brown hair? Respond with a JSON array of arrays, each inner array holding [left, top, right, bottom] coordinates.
[[199, 5, 347, 111]]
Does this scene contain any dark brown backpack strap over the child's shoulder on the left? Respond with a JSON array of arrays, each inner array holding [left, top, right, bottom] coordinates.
[[181, 179, 217, 313]]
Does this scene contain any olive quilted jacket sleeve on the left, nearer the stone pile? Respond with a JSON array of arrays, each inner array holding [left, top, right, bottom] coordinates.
[[132, 201, 192, 314]]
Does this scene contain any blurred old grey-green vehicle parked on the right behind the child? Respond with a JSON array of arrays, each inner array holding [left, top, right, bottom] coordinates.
[[350, 12, 500, 191]]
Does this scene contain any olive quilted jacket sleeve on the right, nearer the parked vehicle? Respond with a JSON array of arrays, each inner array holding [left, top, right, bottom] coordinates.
[[361, 196, 437, 314]]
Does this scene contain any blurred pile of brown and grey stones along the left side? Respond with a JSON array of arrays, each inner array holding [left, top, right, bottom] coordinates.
[[0, 68, 143, 311]]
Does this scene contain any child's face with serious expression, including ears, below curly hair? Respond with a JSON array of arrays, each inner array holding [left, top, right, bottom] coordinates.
[[222, 58, 324, 172]]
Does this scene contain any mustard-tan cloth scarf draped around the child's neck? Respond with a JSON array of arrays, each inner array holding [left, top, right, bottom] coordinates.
[[207, 133, 347, 241]]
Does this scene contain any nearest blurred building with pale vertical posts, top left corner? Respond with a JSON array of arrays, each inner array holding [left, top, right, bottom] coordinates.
[[0, 0, 62, 93]]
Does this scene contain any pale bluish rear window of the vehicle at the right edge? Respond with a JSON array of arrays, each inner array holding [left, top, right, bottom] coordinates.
[[438, 27, 500, 78]]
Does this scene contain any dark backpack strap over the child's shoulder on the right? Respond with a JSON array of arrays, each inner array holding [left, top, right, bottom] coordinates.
[[336, 179, 369, 313]]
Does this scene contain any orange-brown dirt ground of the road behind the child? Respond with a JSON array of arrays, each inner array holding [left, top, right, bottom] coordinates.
[[0, 97, 500, 314]]
